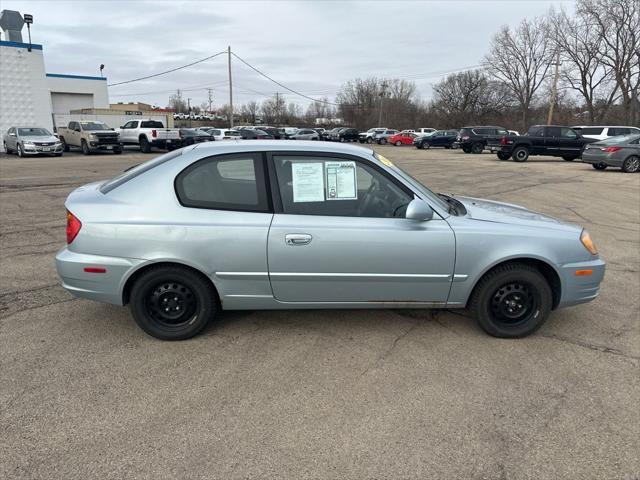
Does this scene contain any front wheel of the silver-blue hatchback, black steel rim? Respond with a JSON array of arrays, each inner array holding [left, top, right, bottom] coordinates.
[[469, 262, 553, 338]]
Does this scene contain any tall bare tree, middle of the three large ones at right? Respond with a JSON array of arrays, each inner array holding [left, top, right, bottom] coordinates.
[[549, 9, 618, 124]]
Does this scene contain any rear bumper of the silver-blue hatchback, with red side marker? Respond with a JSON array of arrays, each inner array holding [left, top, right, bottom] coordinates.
[[56, 247, 144, 305]]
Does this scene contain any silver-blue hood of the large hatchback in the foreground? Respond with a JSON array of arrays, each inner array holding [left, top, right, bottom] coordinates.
[[453, 195, 582, 231]]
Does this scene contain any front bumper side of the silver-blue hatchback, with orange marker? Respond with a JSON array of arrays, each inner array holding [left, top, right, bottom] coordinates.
[[558, 258, 606, 308]]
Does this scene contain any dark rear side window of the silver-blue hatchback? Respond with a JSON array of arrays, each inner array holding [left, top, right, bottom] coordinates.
[[175, 153, 269, 212]]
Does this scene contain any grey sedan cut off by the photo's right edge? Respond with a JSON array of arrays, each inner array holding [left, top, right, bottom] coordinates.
[[582, 134, 640, 173]]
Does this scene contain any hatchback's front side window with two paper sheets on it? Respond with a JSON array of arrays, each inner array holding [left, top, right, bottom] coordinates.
[[273, 155, 413, 218]]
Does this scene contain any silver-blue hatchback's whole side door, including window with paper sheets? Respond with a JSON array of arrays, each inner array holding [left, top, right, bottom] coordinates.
[[267, 154, 455, 303]]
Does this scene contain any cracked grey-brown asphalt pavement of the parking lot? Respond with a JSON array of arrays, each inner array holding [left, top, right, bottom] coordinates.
[[0, 147, 640, 479]]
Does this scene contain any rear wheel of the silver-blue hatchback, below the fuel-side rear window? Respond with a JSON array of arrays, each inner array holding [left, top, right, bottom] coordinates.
[[130, 266, 218, 340]]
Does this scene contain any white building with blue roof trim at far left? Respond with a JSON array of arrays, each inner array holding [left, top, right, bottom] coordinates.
[[0, 40, 109, 148]]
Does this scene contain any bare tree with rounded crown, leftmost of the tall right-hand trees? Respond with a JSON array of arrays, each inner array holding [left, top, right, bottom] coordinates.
[[486, 19, 555, 130]]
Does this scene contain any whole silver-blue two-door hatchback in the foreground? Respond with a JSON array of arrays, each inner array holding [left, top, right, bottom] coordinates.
[[56, 140, 605, 340]]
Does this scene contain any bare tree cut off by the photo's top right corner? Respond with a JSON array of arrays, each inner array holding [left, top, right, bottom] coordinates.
[[577, 0, 640, 125]]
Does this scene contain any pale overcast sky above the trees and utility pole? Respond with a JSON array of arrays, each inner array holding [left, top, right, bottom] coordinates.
[[2, 0, 573, 110]]
